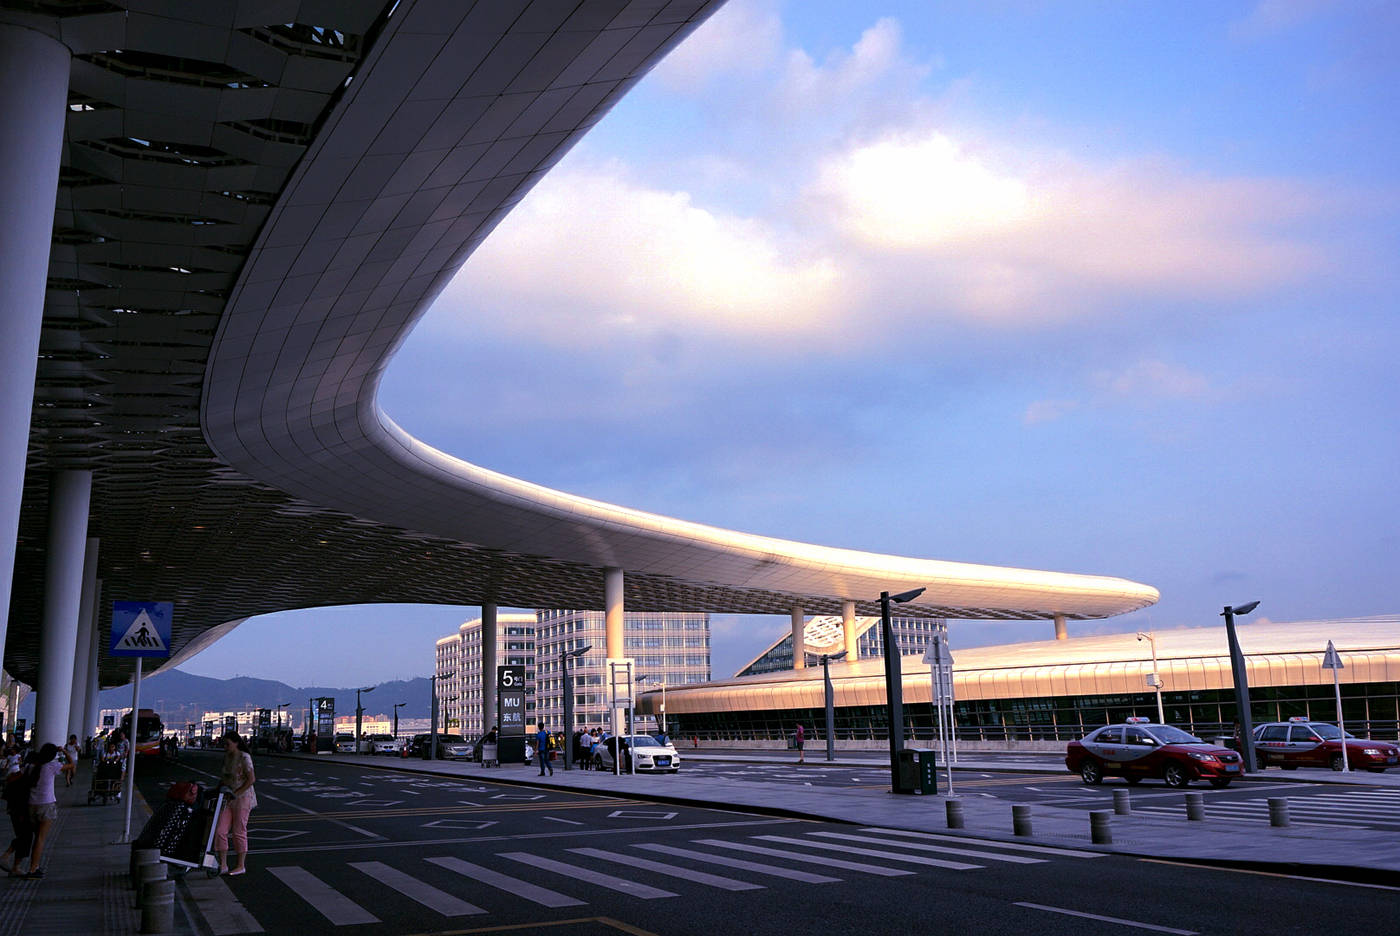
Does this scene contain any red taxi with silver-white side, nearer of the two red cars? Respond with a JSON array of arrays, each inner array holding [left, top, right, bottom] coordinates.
[[1064, 718, 1243, 789]]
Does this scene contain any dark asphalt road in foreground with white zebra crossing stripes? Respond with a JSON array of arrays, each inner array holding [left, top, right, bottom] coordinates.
[[140, 754, 1400, 936]]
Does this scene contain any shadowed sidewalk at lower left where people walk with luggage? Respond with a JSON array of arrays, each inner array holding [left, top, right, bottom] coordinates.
[[0, 760, 161, 936]]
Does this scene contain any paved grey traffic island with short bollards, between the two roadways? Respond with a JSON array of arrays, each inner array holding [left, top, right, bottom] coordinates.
[[303, 751, 1400, 886]]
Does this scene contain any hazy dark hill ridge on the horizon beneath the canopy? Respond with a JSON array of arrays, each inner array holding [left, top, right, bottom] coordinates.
[[20, 669, 431, 728]]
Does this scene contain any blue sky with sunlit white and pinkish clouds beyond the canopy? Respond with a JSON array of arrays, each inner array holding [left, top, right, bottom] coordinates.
[[182, 0, 1400, 686]]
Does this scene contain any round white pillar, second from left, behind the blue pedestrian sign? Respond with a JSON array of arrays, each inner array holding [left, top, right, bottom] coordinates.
[[34, 471, 92, 747]]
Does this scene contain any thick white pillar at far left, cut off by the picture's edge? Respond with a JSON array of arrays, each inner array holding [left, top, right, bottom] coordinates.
[[0, 22, 70, 679]]
